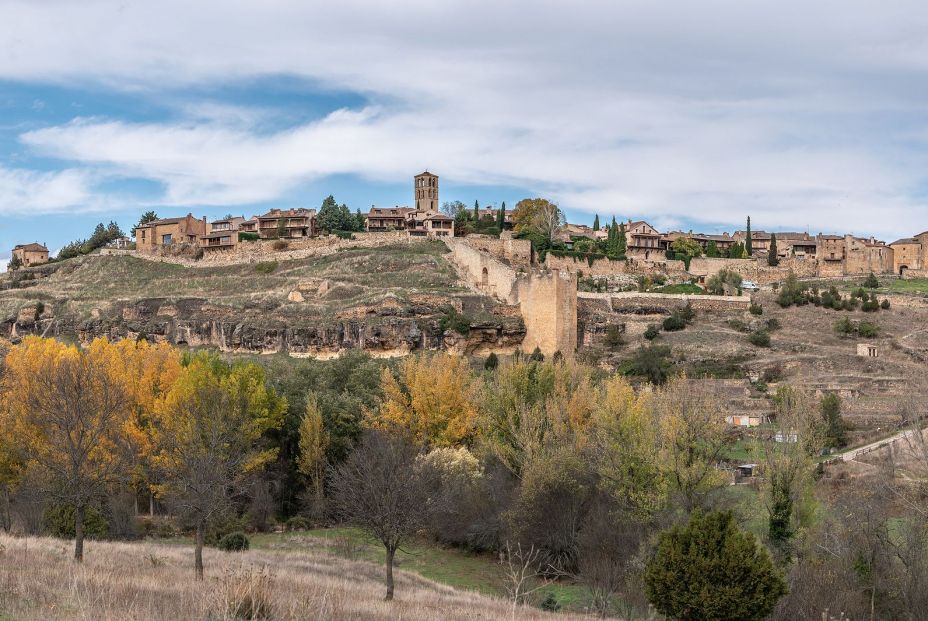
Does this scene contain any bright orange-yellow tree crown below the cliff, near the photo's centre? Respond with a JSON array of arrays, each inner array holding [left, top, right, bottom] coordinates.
[[368, 354, 476, 447]]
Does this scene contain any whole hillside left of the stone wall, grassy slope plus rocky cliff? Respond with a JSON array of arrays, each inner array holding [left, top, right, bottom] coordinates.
[[0, 241, 523, 355]]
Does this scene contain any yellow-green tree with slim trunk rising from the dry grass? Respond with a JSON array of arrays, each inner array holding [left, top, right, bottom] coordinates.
[[151, 353, 287, 580]]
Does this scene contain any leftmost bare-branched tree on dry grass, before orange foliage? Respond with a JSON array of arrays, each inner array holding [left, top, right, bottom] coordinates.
[[26, 353, 132, 562]]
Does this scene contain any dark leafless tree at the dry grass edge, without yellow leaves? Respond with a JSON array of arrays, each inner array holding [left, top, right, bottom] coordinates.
[[332, 430, 427, 601]]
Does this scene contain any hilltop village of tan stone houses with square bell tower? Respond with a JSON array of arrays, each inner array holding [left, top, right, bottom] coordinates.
[[10, 171, 928, 282]]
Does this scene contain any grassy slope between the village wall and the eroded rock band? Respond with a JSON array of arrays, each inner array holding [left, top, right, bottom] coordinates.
[[0, 241, 460, 318]]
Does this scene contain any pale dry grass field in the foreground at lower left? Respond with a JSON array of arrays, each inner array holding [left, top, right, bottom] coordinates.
[[0, 535, 588, 621]]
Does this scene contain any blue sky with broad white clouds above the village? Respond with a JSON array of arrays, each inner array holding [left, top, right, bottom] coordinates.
[[0, 0, 928, 265]]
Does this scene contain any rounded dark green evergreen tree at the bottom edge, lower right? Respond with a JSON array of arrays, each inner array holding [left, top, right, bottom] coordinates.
[[644, 512, 786, 621]]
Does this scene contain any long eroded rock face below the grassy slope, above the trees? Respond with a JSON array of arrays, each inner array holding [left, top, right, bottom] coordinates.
[[0, 298, 525, 357]]
